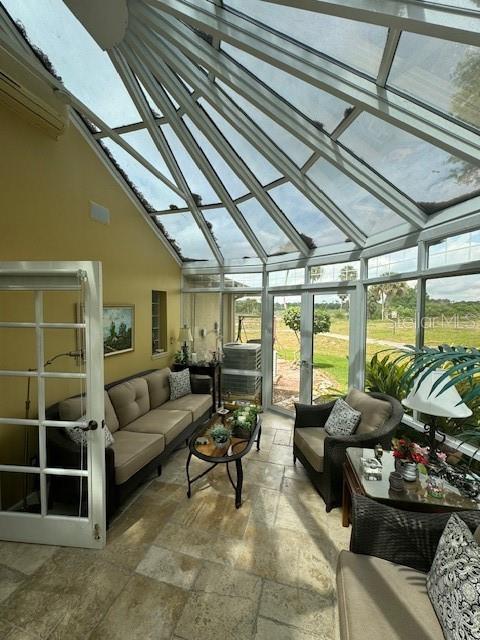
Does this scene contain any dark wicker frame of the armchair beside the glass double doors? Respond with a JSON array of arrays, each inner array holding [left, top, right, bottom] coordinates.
[[293, 393, 403, 511]]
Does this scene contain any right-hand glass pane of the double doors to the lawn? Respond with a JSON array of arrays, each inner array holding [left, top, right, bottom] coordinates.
[[312, 292, 350, 404]]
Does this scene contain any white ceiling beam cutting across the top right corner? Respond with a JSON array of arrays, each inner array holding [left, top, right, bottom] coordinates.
[[258, 0, 480, 47]]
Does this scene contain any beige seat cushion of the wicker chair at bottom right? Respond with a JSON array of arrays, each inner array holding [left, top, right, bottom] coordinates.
[[337, 551, 444, 640]]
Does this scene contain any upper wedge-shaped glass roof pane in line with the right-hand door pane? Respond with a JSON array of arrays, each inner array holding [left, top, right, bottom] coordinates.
[[198, 98, 282, 184]]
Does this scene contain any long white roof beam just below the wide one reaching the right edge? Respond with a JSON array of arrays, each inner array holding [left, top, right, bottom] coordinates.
[[129, 6, 427, 226]]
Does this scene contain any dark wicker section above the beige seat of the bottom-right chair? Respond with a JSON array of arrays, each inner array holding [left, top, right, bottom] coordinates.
[[350, 495, 480, 573]]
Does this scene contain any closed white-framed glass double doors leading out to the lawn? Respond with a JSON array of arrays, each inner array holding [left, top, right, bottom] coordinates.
[[264, 287, 358, 412]]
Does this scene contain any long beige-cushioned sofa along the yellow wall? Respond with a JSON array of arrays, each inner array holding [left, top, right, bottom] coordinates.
[[47, 368, 213, 516]]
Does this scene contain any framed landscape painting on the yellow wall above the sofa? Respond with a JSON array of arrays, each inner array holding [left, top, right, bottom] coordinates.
[[103, 304, 135, 358]]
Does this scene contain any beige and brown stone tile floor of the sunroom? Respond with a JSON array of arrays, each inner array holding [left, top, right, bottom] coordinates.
[[0, 413, 350, 640]]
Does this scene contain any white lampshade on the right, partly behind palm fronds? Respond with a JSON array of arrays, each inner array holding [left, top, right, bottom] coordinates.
[[402, 370, 472, 418]]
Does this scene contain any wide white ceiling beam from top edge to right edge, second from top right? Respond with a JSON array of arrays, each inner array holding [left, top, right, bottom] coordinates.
[[144, 0, 480, 163]]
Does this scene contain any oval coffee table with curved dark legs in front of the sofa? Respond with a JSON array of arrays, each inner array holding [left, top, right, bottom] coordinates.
[[186, 414, 262, 509]]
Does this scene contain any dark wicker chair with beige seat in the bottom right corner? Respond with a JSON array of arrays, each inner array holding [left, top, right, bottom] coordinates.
[[336, 495, 480, 640]]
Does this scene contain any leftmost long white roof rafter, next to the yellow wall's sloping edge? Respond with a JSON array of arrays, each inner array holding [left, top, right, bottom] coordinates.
[[109, 49, 224, 264]]
